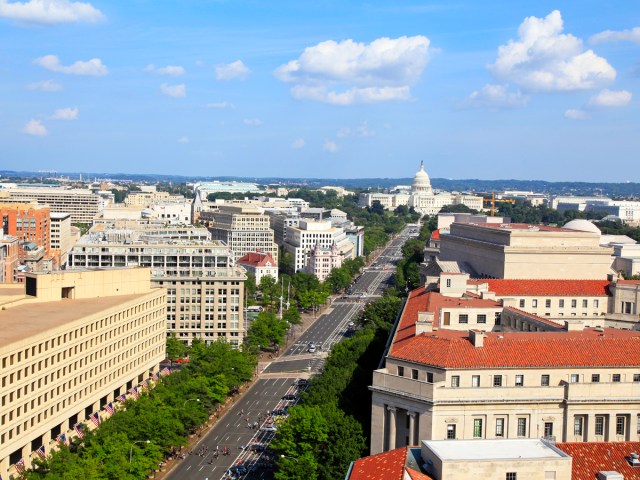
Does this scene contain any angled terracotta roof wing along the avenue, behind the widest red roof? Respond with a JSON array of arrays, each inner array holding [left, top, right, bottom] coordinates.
[[391, 287, 501, 352]]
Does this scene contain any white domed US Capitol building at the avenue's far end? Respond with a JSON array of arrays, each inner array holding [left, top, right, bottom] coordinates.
[[358, 162, 482, 215]]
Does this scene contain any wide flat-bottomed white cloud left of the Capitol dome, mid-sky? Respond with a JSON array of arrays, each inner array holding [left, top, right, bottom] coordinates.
[[274, 35, 430, 105]]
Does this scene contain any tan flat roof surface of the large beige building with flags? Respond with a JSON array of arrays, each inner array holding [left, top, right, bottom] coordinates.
[[0, 290, 155, 348]]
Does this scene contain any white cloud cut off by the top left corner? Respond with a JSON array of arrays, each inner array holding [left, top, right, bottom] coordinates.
[[0, 0, 106, 25]]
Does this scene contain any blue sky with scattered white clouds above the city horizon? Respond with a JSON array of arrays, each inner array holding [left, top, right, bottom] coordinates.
[[0, 0, 640, 182]]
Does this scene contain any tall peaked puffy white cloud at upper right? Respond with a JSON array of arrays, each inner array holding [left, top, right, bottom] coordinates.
[[489, 10, 616, 92]]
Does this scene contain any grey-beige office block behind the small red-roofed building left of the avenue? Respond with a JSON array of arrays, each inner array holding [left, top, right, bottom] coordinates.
[[200, 205, 278, 264]]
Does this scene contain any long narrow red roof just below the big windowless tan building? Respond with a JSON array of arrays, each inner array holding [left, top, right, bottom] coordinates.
[[482, 279, 609, 297]]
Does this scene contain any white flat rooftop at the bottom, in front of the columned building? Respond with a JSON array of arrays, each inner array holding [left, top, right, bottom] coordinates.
[[422, 438, 570, 461]]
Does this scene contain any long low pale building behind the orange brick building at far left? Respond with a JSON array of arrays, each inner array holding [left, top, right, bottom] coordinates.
[[0, 186, 103, 225]]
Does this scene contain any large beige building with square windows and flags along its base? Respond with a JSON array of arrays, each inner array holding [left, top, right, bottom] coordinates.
[[0, 269, 166, 478]]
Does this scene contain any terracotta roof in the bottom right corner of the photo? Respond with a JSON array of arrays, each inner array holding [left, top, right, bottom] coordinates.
[[556, 442, 640, 480]]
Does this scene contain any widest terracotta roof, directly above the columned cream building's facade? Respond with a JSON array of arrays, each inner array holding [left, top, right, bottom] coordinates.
[[389, 329, 640, 368]]
